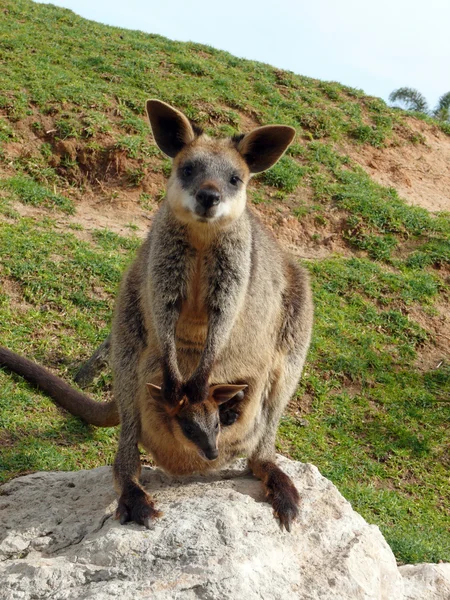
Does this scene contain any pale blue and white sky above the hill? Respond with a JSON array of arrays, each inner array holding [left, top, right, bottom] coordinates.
[[34, 0, 450, 108]]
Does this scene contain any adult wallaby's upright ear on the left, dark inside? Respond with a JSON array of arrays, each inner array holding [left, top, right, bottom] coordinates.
[[146, 100, 195, 158]]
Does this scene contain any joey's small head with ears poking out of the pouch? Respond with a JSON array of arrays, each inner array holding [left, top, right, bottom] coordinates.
[[147, 383, 247, 461]]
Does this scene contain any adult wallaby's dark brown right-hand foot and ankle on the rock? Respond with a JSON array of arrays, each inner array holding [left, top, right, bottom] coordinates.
[[249, 461, 300, 531]]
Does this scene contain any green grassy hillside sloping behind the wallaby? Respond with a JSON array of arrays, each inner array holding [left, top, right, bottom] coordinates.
[[0, 0, 450, 562]]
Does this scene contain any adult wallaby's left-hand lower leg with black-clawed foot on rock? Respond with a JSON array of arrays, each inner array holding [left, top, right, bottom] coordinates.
[[114, 415, 161, 528]]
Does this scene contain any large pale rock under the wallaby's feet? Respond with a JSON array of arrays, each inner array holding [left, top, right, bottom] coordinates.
[[0, 457, 448, 600]]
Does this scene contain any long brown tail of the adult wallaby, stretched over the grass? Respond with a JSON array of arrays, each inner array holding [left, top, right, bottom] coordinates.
[[0, 346, 120, 427]]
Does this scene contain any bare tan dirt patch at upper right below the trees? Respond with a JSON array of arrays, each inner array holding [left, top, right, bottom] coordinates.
[[341, 118, 450, 212]]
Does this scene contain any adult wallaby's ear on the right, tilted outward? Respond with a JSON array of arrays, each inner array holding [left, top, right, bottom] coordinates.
[[237, 125, 295, 173]]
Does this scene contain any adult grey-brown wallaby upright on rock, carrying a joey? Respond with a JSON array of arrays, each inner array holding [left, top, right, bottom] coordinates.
[[0, 100, 313, 530]]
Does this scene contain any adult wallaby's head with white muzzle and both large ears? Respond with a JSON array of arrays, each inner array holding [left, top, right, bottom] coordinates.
[[147, 100, 295, 227]]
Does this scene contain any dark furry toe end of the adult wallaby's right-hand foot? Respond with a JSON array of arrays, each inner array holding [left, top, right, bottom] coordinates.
[[266, 469, 300, 531]]
